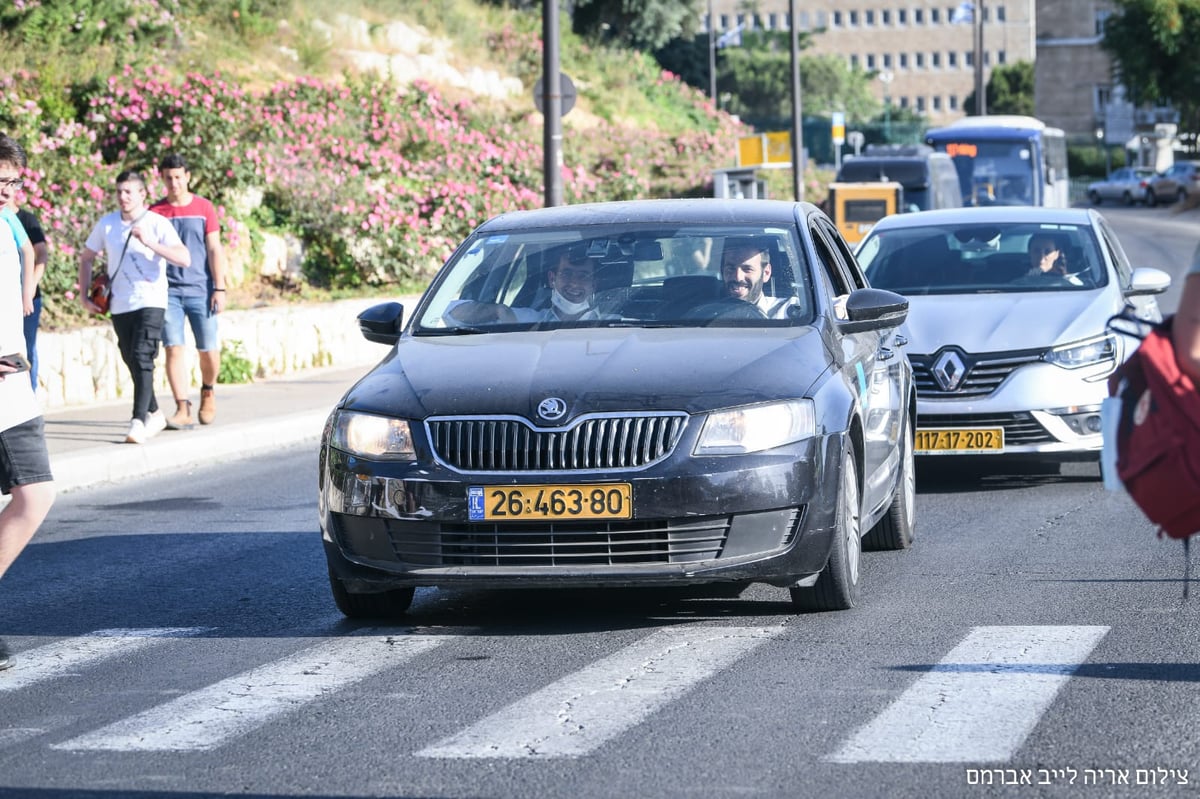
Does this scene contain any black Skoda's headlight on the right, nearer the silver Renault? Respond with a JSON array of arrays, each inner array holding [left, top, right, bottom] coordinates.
[[696, 400, 817, 455]]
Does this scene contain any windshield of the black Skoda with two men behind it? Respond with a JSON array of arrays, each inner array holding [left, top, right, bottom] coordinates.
[[412, 223, 812, 335]]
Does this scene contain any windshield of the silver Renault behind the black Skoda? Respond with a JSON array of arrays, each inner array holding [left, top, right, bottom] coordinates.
[[858, 223, 1108, 294]]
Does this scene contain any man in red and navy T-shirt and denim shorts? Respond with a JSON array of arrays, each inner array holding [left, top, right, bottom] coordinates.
[[150, 154, 226, 429]]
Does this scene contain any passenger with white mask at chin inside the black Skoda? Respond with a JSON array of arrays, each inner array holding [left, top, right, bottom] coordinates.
[[445, 247, 618, 324]]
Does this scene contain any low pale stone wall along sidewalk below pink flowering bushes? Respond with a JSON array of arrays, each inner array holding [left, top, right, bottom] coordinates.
[[37, 296, 418, 410]]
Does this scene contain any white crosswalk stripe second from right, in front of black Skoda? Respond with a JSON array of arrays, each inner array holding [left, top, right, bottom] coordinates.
[[416, 626, 784, 758]]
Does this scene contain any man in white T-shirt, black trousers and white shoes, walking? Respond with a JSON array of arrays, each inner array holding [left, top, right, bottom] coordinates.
[[79, 172, 191, 444]]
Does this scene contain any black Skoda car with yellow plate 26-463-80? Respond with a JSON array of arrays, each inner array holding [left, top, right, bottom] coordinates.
[[319, 199, 916, 617]]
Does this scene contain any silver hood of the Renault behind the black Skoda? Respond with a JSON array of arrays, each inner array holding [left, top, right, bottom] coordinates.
[[905, 289, 1120, 355]]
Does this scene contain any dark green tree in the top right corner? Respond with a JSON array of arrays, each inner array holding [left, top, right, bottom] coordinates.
[[1100, 0, 1200, 131]]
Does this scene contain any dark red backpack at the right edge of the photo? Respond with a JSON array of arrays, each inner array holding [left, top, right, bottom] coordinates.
[[1109, 318, 1200, 545]]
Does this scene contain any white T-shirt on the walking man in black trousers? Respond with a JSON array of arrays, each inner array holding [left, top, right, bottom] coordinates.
[[85, 211, 184, 313]]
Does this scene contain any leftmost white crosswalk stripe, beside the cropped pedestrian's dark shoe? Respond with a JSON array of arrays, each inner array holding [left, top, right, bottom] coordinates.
[[0, 627, 211, 693]]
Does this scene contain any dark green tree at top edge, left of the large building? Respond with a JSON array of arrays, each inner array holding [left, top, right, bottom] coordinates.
[[571, 0, 702, 50]]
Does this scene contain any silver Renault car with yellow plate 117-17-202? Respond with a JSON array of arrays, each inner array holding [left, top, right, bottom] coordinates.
[[857, 206, 1171, 465]]
